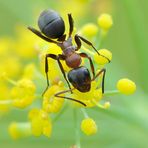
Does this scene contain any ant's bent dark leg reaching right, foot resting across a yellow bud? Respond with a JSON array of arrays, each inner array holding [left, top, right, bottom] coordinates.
[[75, 34, 110, 63]]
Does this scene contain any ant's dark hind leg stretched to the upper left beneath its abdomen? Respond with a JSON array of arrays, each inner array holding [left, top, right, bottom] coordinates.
[[28, 27, 58, 44]]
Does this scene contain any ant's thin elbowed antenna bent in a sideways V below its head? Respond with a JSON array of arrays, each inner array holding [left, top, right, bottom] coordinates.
[[54, 88, 86, 106]]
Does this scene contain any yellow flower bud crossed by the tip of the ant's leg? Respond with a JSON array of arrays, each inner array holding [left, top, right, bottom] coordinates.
[[94, 49, 112, 65]]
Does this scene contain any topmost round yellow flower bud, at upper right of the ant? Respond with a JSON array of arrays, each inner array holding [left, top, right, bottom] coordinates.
[[98, 13, 113, 30]]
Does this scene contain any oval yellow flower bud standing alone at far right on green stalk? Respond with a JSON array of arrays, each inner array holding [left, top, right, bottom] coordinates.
[[117, 78, 136, 95]]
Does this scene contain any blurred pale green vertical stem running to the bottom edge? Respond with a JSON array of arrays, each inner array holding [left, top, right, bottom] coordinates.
[[74, 108, 81, 148]]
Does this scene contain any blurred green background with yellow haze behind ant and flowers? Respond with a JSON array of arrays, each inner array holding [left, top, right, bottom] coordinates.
[[0, 0, 148, 148]]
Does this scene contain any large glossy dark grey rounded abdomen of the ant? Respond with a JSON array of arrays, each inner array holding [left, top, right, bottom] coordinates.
[[38, 9, 65, 39]]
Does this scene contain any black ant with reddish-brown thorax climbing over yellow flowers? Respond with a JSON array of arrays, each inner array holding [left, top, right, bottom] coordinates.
[[28, 9, 110, 106]]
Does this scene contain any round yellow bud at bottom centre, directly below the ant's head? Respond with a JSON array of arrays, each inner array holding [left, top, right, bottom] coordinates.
[[81, 118, 97, 136]]
